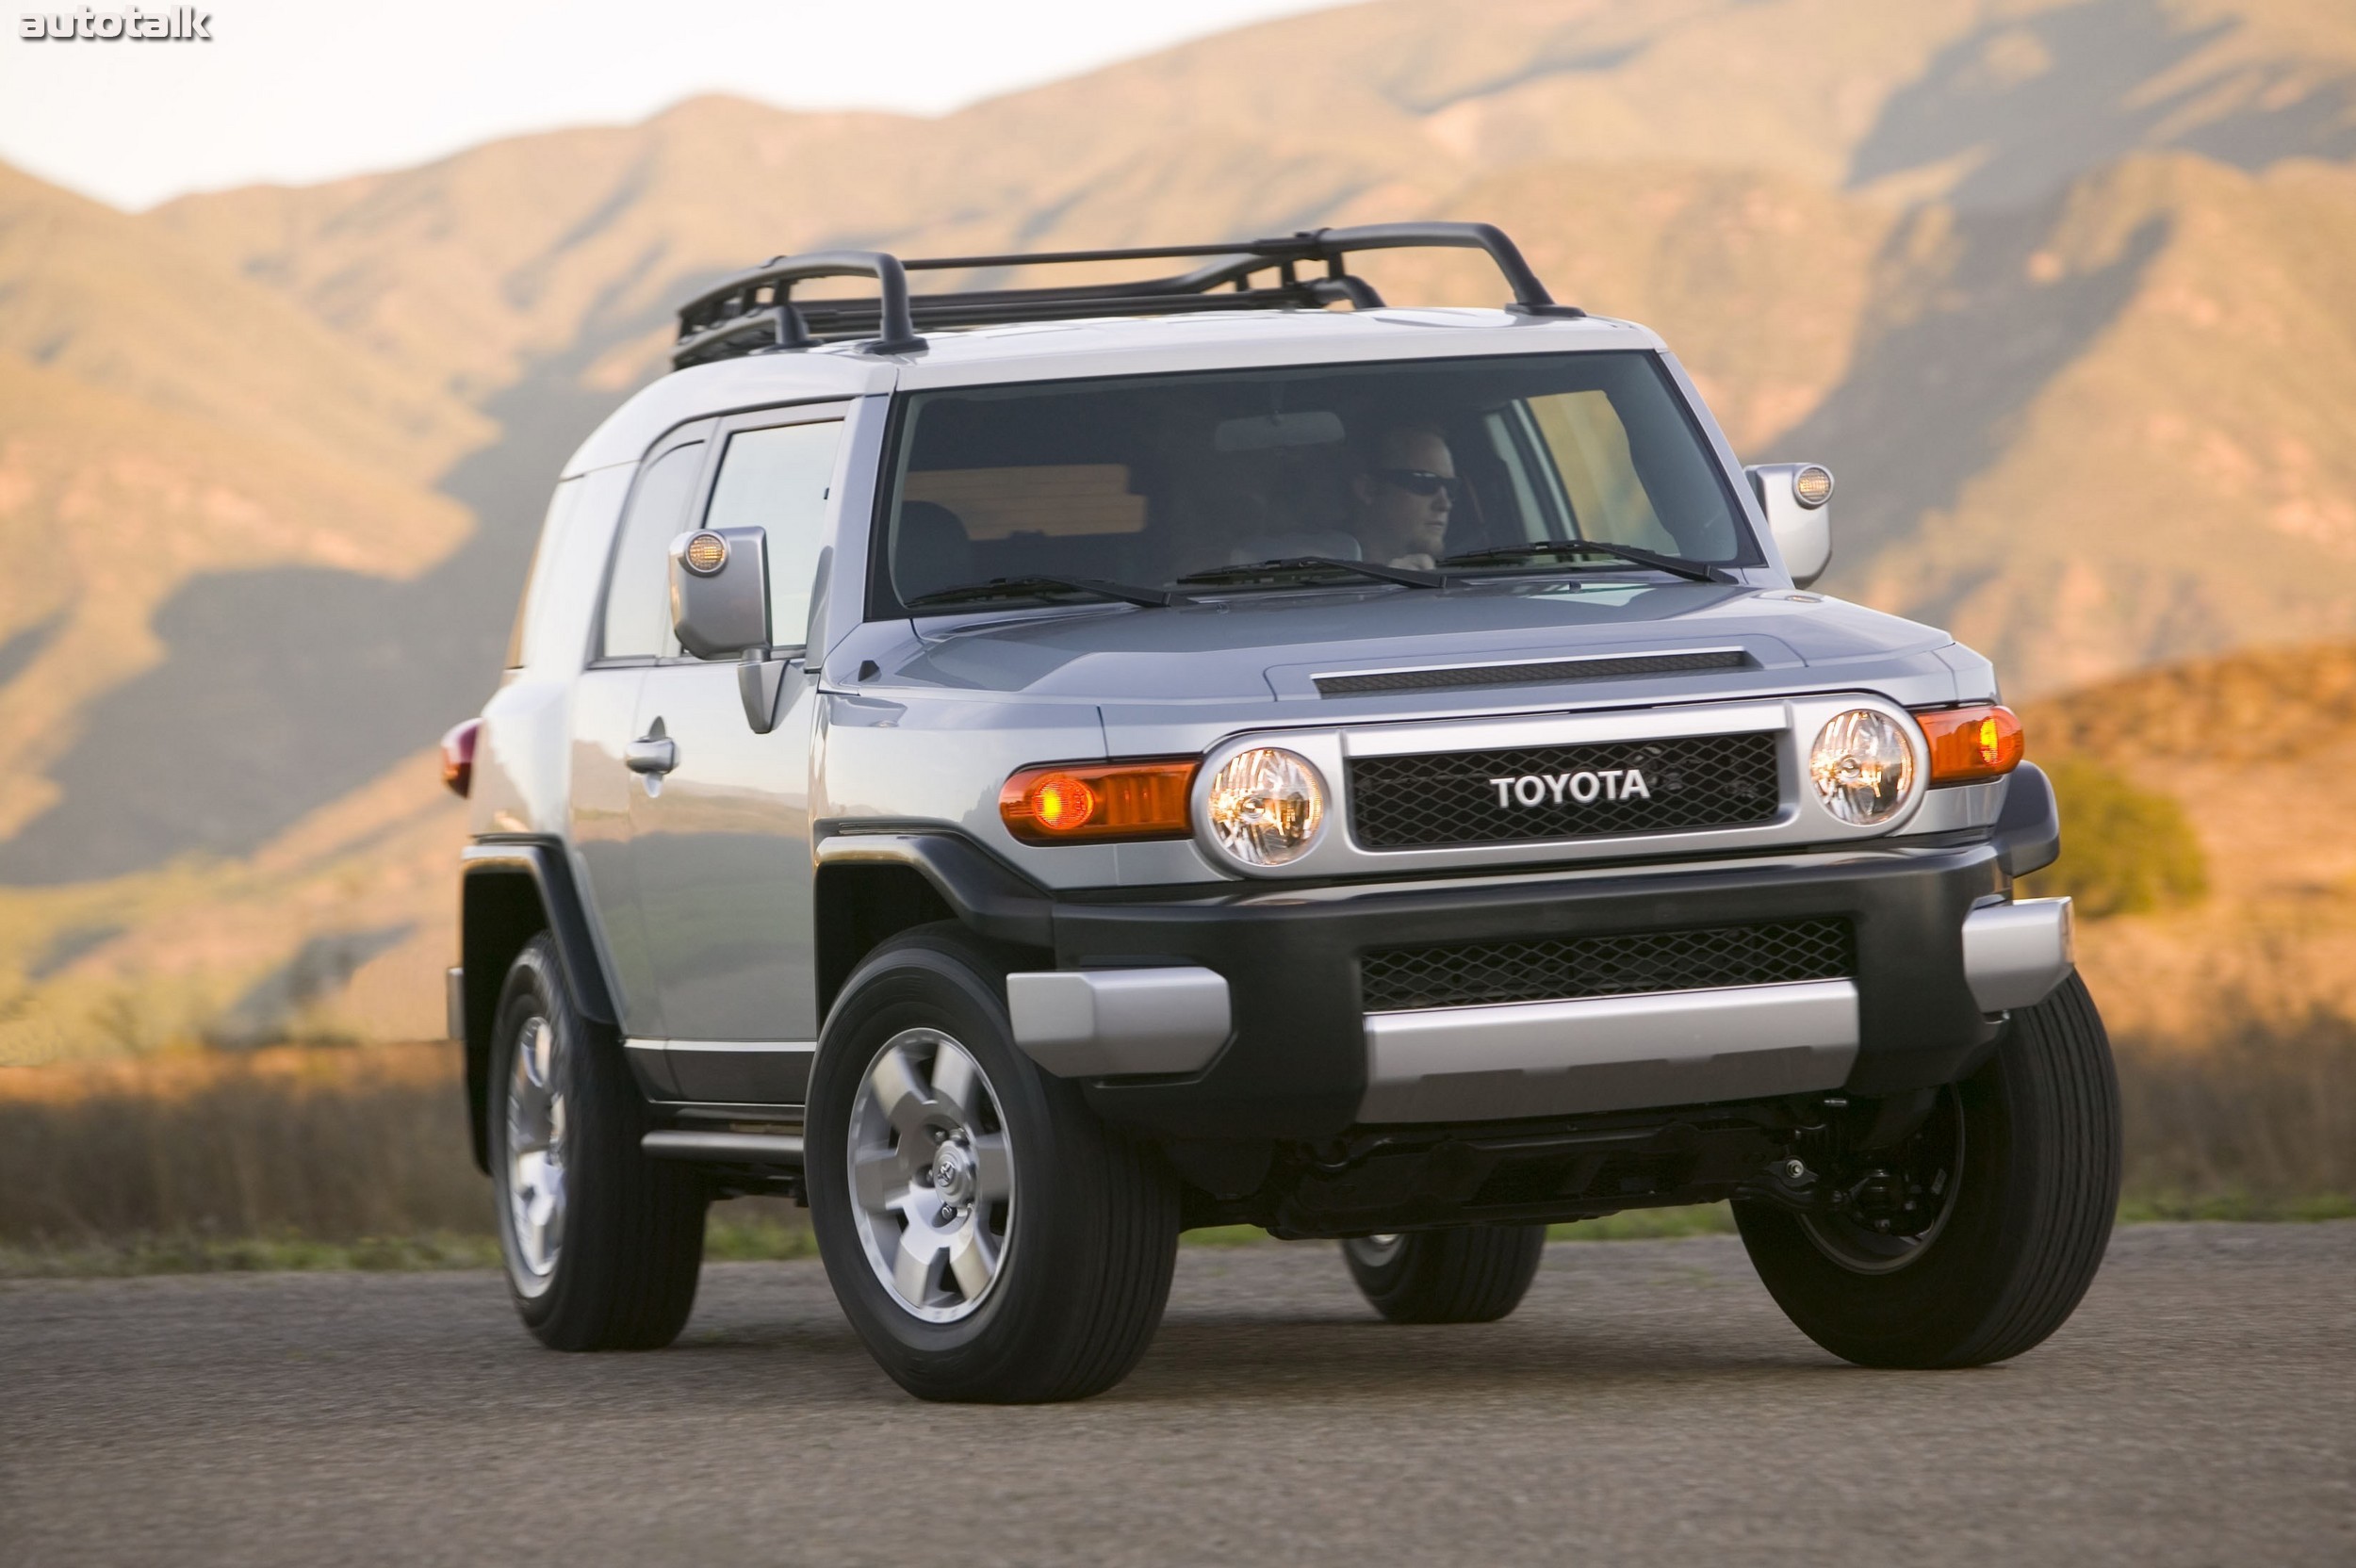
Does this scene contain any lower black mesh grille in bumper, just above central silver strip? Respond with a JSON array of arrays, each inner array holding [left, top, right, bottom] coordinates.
[[1360, 918, 1857, 1012]]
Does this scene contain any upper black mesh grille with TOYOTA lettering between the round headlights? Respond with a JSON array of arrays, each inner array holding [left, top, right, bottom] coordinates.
[[1350, 735, 1779, 850]]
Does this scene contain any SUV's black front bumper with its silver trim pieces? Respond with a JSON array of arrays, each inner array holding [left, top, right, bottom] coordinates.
[[1037, 842, 2069, 1139]]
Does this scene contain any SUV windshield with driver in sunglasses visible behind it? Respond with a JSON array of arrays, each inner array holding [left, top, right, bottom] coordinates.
[[876, 353, 1758, 612]]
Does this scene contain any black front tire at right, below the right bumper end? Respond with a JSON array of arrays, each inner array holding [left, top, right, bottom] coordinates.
[[1734, 974, 2120, 1368]]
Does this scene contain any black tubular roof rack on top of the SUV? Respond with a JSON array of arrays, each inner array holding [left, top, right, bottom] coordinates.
[[672, 223, 1586, 369]]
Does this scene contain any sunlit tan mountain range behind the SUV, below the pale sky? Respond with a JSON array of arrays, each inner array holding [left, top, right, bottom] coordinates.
[[0, 0, 2356, 1059]]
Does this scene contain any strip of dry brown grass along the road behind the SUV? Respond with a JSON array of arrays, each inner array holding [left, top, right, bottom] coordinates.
[[0, 1015, 2356, 1276]]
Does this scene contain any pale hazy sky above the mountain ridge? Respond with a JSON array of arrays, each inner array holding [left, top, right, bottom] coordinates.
[[0, 0, 1336, 207]]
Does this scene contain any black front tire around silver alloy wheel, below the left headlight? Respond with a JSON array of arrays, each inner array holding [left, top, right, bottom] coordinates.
[[804, 925, 1178, 1403]]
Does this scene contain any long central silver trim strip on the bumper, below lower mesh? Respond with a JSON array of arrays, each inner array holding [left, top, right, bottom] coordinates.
[[1360, 979, 1857, 1120]]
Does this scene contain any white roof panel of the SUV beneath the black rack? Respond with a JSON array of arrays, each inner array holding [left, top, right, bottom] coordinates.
[[565, 308, 1661, 476]]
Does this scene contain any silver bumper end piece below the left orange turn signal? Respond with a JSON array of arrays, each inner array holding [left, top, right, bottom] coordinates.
[[1006, 965, 1235, 1078]]
